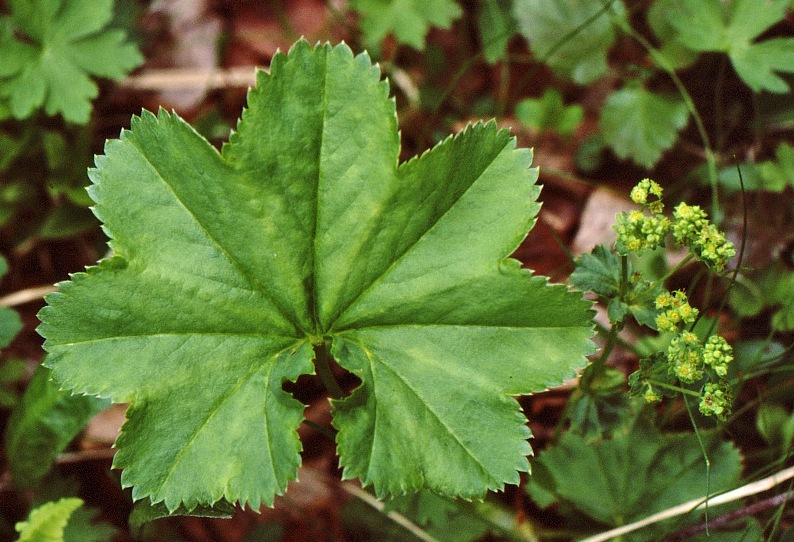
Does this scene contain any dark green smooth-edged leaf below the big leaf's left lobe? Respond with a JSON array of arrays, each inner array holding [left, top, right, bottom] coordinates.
[[5, 366, 108, 487]]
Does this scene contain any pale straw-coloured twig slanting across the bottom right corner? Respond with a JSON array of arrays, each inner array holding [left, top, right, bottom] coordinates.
[[580, 467, 794, 542]]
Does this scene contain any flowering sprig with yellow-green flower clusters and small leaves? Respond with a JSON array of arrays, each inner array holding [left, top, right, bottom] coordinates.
[[571, 179, 736, 420]]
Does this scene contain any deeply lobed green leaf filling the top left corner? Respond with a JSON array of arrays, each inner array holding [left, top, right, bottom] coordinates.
[[0, 0, 143, 124]]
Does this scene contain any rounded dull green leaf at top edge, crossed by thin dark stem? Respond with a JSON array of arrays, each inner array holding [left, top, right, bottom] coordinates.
[[514, 0, 626, 85]]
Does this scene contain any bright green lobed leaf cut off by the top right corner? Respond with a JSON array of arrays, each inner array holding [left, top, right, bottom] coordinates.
[[664, 0, 794, 94]]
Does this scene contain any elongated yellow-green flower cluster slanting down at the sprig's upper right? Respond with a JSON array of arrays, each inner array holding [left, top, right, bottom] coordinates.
[[672, 202, 736, 271]]
